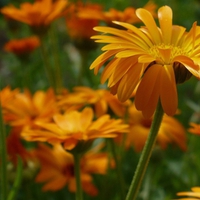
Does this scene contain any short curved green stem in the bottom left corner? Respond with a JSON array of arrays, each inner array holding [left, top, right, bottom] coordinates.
[[7, 156, 23, 200]]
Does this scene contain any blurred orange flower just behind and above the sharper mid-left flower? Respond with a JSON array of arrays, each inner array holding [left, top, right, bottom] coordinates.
[[58, 87, 129, 117]]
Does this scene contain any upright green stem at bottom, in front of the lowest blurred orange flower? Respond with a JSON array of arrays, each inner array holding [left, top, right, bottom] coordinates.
[[73, 152, 83, 200]]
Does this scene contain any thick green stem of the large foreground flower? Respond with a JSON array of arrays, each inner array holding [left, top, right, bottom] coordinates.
[[126, 101, 164, 200]]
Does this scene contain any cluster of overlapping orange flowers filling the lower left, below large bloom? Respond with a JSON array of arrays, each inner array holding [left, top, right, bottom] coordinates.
[[0, 87, 189, 195]]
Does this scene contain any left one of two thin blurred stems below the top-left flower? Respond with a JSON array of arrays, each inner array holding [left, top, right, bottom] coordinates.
[[40, 37, 56, 91]]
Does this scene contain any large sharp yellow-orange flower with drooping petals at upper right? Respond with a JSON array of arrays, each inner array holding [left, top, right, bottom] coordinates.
[[90, 6, 200, 117]]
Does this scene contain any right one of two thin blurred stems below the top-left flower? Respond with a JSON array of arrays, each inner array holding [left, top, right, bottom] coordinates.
[[49, 26, 63, 94]]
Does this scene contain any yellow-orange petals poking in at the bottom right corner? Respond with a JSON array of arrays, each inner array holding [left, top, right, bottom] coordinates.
[[177, 187, 200, 200]]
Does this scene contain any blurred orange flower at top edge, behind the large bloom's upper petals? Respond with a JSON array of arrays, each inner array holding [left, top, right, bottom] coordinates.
[[79, 1, 156, 26]]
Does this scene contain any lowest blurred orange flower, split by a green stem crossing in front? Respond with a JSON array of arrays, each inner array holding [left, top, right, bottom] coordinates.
[[35, 145, 112, 196]]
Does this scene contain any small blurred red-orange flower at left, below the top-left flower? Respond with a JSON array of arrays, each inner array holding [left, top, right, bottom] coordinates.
[[4, 36, 40, 55]]
